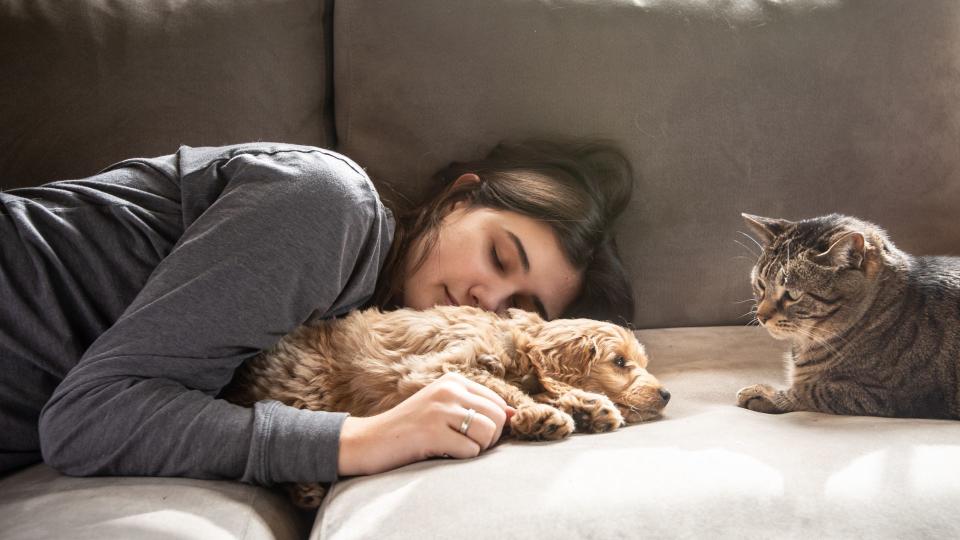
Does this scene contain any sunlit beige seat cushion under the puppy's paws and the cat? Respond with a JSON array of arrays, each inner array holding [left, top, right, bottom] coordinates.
[[311, 327, 960, 540]]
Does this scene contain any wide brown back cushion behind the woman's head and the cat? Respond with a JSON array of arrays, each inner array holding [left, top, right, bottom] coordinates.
[[334, 0, 960, 327]]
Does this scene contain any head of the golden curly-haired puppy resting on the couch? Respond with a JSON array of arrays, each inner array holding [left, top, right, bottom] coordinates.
[[510, 310, 670, 423]]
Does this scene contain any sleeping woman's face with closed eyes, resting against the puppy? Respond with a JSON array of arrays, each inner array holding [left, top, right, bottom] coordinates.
[[403, 203, 582, 318]]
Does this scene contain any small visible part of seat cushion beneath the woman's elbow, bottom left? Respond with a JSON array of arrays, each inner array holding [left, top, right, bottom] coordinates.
[[0, 465, 309, 540]]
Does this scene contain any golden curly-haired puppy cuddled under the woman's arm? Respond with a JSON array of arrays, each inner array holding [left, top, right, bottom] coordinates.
[[222, 306, 670, 508]]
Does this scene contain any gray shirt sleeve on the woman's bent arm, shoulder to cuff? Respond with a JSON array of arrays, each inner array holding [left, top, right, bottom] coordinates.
[[40, 147, 393, 484]]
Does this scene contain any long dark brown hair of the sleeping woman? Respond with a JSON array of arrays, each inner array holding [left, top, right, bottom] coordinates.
[[373, 141, 634, 324]]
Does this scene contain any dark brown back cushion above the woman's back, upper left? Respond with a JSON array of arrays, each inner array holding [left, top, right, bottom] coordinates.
[[0, 0, 333, 189]]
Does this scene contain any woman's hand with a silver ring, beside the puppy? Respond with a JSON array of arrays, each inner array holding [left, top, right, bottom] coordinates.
[[338, 373, 515, 476]]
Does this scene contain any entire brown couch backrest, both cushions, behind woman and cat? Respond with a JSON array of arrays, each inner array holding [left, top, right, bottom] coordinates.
[[0, 0, 960, 327]]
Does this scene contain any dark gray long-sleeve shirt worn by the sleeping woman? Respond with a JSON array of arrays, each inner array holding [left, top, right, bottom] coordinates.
[[0, 143, 394, 484]]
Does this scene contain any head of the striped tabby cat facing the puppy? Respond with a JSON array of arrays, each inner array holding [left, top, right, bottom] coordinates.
[[743, 214, 893, 343]]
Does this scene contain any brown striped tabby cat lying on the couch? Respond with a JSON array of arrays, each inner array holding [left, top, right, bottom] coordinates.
[[737, 214, 960, 418]]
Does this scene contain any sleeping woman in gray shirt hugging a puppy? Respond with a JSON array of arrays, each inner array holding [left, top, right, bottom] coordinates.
[[0, 139, 633, 484]]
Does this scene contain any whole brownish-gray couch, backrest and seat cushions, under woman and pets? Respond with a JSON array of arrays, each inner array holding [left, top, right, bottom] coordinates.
[[0, 0, 960, 540]]
